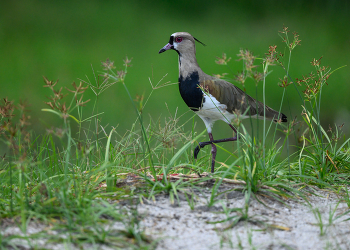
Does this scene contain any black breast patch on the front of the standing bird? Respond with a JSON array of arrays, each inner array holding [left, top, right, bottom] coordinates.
[[179, 71, 205, 111]]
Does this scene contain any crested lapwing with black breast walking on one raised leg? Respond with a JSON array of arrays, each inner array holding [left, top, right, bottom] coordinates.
[[159, 32, 287, 173]]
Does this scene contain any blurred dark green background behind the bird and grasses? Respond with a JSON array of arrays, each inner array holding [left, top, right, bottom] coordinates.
[[0, 0, 350, 146]]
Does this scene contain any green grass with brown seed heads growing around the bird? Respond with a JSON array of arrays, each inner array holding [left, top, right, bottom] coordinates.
[[0, 25, 350, 249]]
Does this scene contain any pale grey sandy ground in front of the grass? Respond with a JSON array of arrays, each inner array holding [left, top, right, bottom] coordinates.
[[0, 185, 350, 250]]
